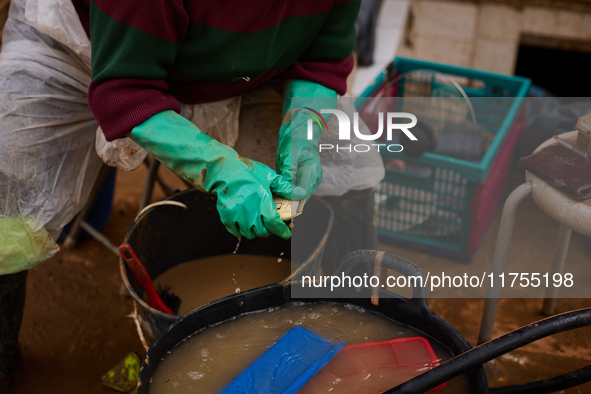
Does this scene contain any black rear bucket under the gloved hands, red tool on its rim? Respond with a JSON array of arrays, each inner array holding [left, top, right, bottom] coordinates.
[[120, 189, 333, 345]]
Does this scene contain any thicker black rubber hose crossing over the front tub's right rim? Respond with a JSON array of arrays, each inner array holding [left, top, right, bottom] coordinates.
[[385, 308, 591, 394]]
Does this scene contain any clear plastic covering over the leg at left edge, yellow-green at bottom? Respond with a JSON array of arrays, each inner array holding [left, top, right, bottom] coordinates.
[[0, 1, 102, 275]]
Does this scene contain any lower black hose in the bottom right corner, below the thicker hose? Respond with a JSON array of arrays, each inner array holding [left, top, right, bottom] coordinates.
[[489, 365, 591, 394]]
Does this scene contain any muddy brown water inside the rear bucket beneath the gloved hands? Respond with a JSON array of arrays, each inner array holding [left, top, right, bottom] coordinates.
[[154, 254, 291, 316]]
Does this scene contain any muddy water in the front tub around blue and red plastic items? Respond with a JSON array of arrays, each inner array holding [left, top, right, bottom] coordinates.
[[148, 303, 470, 394]]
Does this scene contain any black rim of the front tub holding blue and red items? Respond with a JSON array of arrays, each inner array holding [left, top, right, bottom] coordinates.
[[137, 251, 488, 394]]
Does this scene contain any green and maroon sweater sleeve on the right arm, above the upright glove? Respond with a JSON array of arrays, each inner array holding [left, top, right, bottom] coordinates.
[[283, 0, 361, 94]]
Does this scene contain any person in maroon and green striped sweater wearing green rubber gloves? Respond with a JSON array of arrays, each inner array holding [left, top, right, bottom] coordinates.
[[79, 0, 360, 238]]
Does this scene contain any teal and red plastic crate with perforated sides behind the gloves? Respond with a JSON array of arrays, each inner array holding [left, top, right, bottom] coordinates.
[[356, 57, 531, 260]]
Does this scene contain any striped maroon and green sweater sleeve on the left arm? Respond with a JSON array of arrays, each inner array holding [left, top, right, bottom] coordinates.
[[88, 0, 189, 141]]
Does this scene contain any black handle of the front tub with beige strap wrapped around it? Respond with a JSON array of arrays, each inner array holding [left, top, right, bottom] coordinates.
[[336, 249, 428, 308]]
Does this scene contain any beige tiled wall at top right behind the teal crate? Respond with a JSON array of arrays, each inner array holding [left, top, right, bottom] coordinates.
[[397, 0, 591, 74]]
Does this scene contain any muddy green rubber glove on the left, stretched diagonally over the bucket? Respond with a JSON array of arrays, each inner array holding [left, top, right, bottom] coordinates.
[[131, 111, 291, 239]]
